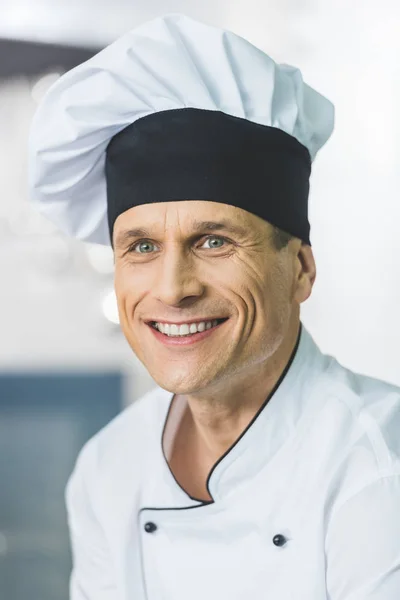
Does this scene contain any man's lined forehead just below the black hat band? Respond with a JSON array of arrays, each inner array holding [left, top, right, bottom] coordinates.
[[114, 200, 267, 245]]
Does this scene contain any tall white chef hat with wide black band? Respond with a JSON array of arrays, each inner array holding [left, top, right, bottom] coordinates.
[[28, 14, 334, 245]]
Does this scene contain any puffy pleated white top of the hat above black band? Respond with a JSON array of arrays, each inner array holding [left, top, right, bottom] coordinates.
[[28, 14, 334, 245]]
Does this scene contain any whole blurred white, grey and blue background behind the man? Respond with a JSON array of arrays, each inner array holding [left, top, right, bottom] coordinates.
[[0, 0, 400, 600]]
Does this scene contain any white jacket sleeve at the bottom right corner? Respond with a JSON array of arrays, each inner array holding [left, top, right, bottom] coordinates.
[[325, 472, 400, 600]]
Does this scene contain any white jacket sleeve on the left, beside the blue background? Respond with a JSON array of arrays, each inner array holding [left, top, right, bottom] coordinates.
[[65, 439, 118, 600]]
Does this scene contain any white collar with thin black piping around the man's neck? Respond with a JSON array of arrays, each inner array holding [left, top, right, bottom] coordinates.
[[158, 323, 327, 502]]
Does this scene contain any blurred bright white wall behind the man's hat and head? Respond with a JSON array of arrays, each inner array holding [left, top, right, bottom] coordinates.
[[0, 0, 400, 402]]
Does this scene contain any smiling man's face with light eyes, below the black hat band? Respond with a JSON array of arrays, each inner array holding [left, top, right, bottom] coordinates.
[[113, 200, 313, 394]]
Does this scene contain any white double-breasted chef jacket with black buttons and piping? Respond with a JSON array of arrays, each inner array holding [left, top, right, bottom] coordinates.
[[66, 325, 400, 600]]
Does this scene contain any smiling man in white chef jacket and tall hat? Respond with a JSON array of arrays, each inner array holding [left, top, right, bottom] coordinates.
[[29, 14, 400, 600]]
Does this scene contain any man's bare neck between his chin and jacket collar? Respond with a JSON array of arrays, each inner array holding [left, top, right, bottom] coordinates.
[[184, 323, 300, 460]]
